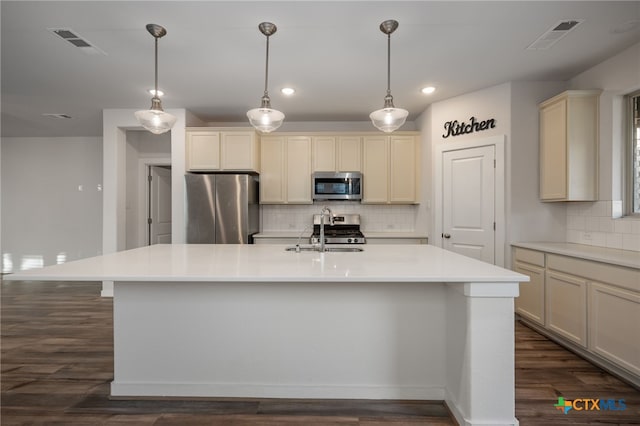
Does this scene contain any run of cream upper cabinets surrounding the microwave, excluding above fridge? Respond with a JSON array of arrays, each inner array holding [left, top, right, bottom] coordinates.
[[260, 132, 420, 204]]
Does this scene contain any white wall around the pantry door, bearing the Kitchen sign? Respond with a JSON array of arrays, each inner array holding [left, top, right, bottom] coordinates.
[[424, 82, 566, 265]]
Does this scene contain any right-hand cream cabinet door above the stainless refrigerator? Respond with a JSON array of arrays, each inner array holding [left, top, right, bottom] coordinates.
[[220, 131, 260, 171]]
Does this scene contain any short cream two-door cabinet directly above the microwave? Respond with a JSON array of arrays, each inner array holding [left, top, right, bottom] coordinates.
[[312, 136, 362, 172]]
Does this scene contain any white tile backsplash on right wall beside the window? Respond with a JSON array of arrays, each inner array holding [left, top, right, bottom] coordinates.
[[567, 201, 640, 251]]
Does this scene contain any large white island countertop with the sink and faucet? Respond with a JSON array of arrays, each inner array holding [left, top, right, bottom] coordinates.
[[4, 244, 529, 283]]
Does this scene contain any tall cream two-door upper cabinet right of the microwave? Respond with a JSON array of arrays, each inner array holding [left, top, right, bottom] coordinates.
[[362, 135, 420, 204]]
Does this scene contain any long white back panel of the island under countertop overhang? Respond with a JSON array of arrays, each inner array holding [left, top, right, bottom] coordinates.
[[111, 282, 447, 400]]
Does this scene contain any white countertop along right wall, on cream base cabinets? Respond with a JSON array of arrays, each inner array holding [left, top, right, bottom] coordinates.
[[511, 242, 640, 269]]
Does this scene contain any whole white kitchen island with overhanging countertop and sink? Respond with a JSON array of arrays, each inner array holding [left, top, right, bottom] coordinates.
[[7, 244, 528, 425]]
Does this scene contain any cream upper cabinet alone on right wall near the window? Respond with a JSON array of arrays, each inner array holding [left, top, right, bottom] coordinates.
[[540, 90, 601, 201]]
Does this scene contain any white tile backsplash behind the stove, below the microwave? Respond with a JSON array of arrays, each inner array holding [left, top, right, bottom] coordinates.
[[261, 201, 418, 232]]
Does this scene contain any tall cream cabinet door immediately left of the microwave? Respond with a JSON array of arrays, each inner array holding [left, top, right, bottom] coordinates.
[[286, 136, 312, 204]]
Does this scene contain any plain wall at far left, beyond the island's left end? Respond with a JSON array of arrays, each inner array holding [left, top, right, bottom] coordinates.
[[1, 137, 102, 272]]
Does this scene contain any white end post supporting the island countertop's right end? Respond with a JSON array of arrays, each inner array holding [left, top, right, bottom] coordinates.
[[446, 283, 518, 426]]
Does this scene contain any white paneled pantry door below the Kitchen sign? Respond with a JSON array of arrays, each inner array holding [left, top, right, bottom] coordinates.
[[441, 145, 495, 263]]
